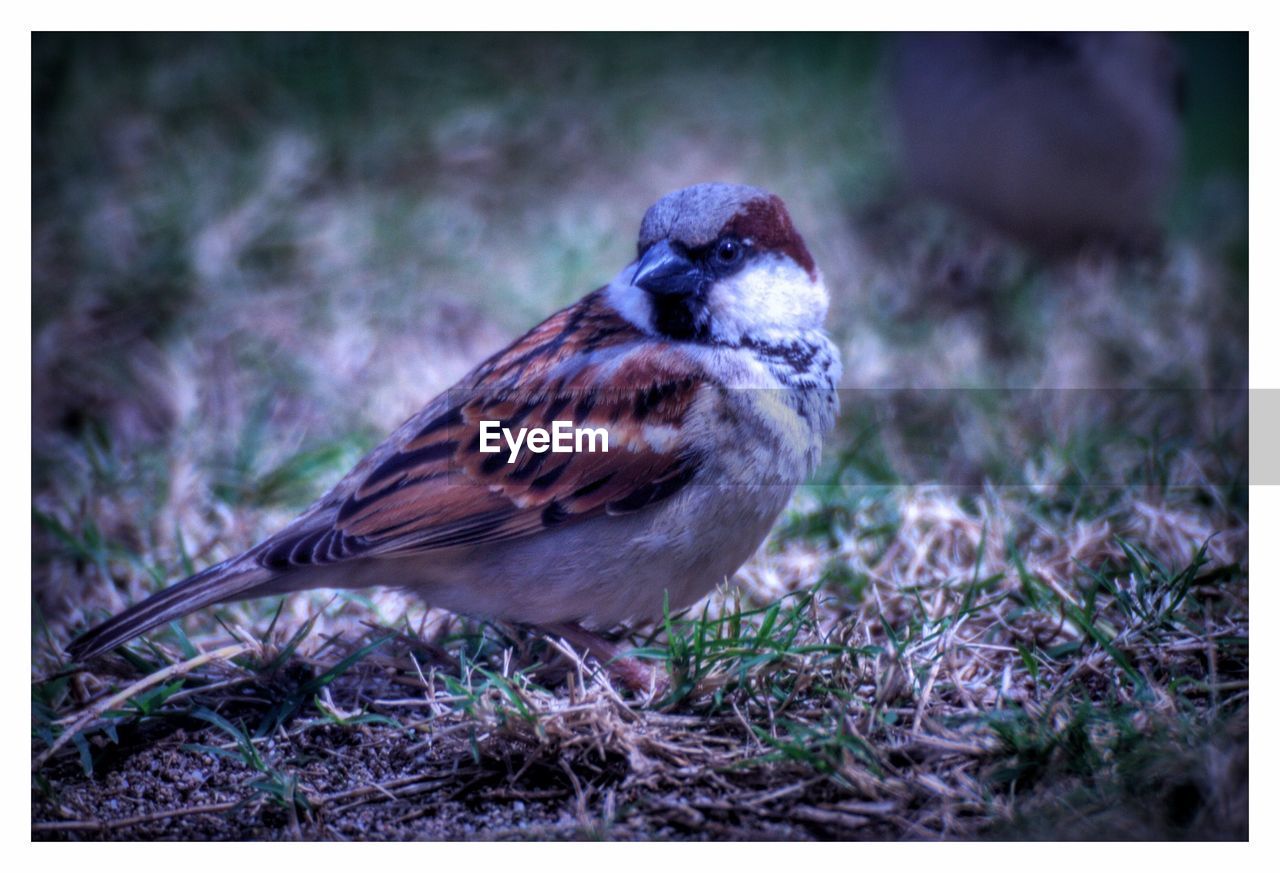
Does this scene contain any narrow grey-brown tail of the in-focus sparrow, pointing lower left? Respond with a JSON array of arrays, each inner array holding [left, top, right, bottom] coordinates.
[[67, 558, 275, 661]]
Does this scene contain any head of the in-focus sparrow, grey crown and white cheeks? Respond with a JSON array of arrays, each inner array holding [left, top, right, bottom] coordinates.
[[611, 183, 827, 344]]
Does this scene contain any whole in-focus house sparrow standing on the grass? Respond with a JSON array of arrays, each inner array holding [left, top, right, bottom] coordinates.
[[68, 184, 840, 686]]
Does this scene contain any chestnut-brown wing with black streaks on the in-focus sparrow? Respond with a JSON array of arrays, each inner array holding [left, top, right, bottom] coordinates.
[[259, 290, 709, 570]]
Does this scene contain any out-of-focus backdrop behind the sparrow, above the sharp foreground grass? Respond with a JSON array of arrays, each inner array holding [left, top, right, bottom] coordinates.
[[32, 35, 1248, 642]]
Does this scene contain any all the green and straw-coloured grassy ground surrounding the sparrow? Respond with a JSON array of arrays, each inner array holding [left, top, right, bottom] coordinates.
[[32, 35, 1249, 840]]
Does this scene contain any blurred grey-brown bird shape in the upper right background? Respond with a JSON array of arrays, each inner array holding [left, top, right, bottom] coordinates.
[[888, 32, 1187, 255]]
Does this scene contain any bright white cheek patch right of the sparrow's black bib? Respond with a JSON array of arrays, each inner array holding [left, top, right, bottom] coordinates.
[[708, 255, 828, 340]]
